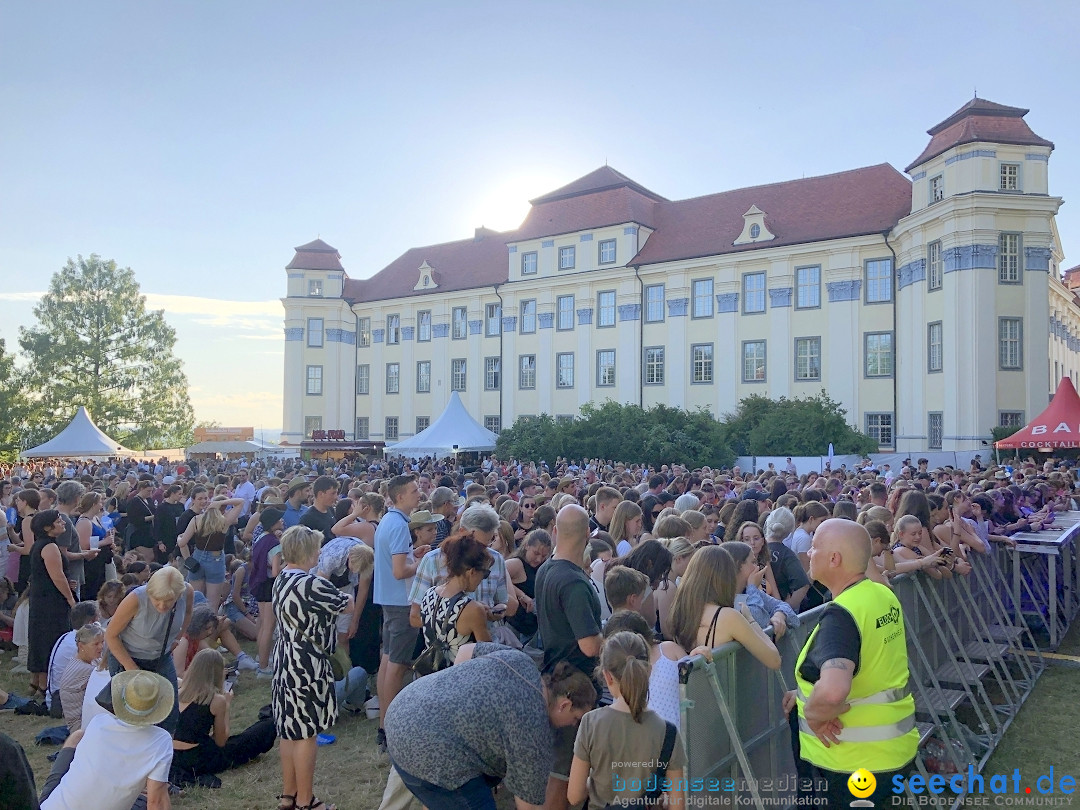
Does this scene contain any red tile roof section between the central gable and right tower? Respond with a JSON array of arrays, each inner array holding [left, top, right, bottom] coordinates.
[[630, 163, 912, 266]]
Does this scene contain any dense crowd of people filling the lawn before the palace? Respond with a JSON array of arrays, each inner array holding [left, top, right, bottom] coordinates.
[[0, 457, 1077, 810]]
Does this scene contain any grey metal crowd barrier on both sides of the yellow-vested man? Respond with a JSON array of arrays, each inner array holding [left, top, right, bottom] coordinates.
[[679, 520, 1080, 808]]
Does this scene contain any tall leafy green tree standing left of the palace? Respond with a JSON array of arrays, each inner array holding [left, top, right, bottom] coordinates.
[[18, 255, 194, 449]]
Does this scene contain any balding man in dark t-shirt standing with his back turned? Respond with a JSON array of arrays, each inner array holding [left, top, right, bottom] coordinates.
[[536, 503, 604, 810]]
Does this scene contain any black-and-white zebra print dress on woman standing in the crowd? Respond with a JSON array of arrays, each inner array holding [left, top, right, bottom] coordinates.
[[270, 569, 348, 740]]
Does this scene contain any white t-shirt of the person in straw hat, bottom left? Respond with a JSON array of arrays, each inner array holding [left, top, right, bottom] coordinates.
[[41, 712, 173, 810]]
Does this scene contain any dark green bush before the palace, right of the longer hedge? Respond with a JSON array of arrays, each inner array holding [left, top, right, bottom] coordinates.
[[725, 389, 878, 456]]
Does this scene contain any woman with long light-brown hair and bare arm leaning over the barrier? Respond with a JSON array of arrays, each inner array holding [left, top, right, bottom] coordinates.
[[672, 545, 780, 670]]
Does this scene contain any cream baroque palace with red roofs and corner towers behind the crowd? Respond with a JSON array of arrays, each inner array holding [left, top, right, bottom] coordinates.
[[282, 98, 1080, 451]]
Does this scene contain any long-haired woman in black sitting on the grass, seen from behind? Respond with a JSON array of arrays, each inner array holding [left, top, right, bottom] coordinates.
[[173, 649, 276, 787]]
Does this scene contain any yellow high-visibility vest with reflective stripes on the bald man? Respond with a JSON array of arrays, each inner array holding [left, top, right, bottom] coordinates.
[[795, 579, 919, 773]]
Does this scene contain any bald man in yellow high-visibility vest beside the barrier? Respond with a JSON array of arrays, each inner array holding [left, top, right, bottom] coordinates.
[[784, 519, 919, 807]]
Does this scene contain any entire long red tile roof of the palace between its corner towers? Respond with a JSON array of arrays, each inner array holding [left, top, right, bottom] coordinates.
[[339, 163, 912, 302]]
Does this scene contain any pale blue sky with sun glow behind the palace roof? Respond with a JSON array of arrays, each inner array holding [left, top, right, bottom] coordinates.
[[0, 0, 1080, 435]]
